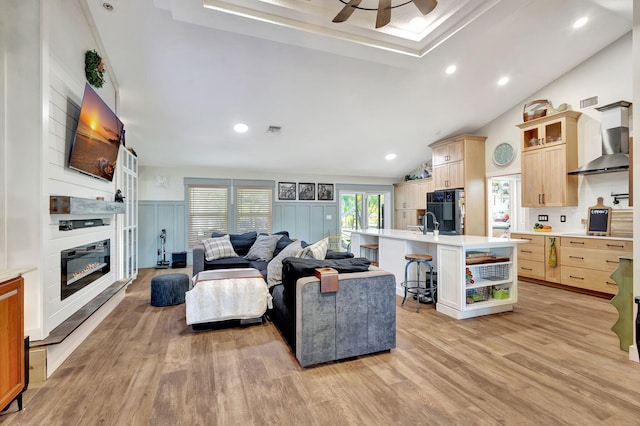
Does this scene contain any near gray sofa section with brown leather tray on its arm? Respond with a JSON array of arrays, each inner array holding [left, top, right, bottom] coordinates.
[[269, 258, 396, 367]]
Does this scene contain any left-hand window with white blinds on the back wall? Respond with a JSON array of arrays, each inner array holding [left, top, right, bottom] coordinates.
[[187, 185, 229, 247]]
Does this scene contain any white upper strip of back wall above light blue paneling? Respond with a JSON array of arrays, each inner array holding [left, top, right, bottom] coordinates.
[[138, 165, 398, 201]]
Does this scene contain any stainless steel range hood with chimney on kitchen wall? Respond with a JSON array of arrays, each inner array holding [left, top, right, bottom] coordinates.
[[569, 101, 631, 175]]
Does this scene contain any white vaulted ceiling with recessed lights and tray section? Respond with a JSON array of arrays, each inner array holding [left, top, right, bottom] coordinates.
[[86, 0, 633, 177]]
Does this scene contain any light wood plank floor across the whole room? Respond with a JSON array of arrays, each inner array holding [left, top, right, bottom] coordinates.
[[0, 270, 640, 426]]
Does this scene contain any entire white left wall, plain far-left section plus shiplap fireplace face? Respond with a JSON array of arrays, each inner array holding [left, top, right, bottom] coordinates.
[[0, 0, 117, 340]]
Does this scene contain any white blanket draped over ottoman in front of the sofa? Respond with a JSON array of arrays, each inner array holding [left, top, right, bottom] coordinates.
[[185, 278, 271, 325]]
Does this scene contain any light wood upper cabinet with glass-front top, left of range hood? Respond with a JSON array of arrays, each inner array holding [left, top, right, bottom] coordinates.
[[518, 111, 581, 207]]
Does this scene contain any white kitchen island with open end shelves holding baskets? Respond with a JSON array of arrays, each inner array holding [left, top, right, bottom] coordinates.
[[351, 229, 527, 319]]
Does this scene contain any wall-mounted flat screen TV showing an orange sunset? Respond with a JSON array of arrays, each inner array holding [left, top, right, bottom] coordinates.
[[69, 84, 124, 182]]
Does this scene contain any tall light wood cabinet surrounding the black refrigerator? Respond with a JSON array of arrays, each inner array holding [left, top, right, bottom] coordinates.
[[430, 135, 487, 235]]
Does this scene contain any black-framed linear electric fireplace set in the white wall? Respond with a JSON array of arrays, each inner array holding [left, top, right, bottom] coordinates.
[[60, 240, 111, 300]]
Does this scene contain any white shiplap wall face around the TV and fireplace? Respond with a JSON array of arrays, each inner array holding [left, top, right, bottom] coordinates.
[[40, 1, 124, 334]]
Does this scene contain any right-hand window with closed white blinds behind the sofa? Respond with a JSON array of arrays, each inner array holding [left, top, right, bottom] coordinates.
[[236, 186, 273, 234]]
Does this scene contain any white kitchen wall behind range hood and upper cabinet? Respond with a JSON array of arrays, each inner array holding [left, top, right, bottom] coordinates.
[[476, 33, 633, 232]]
